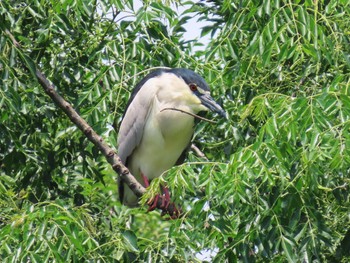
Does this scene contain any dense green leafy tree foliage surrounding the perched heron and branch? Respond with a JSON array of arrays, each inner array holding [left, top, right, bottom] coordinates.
[[0, 0, 350, 262]]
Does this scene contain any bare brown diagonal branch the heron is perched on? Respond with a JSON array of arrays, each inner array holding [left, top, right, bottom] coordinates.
[[6, 30, 179, 218]]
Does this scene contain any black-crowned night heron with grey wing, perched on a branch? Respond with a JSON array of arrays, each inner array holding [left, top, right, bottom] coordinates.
[[118, 68, 226, 211]]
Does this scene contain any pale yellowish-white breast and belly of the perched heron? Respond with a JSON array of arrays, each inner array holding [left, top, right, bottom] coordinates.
[[131, 101, 194, 182]]
